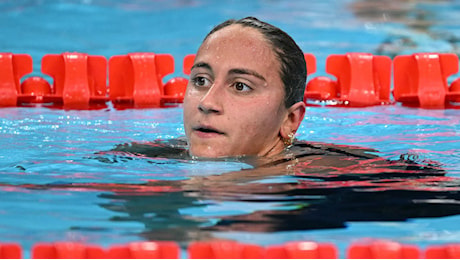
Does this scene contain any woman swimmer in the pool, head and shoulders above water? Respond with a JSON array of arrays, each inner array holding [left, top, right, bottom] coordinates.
[[108, 17, 442, 180]]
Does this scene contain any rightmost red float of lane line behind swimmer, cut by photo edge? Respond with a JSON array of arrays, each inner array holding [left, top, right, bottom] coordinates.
[[393, 53, 460, 108]]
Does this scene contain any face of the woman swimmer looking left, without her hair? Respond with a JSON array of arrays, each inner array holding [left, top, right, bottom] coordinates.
[[184, 25, 303, 157]]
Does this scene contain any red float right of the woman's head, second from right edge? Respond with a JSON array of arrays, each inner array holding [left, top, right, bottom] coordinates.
[[305, 53, 391, 107]]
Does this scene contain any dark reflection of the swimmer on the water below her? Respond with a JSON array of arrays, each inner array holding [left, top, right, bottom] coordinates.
[[94, 170, 460, 241]]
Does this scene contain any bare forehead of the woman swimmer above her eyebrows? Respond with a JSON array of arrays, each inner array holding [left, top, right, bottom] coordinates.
[[196, 24, 280, 74]]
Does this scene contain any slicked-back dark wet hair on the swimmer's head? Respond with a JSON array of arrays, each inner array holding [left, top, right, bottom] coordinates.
[[203, 17, 307, 108]]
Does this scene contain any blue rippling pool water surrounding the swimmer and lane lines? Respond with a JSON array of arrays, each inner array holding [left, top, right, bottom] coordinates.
[[0, 0, 460, 257]]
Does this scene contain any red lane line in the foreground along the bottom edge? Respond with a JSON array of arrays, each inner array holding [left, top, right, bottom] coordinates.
[[4, 239, 460, 259]]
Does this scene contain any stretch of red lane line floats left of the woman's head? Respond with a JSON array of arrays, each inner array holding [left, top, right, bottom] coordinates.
[[0, 53, 188, 108]]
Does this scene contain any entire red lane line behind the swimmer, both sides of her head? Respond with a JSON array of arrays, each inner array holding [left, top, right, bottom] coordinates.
[[0, 53, 460, 109]]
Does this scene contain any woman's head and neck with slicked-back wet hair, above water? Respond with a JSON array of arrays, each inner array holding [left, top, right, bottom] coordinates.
[[184, 17, 307, 158]]
